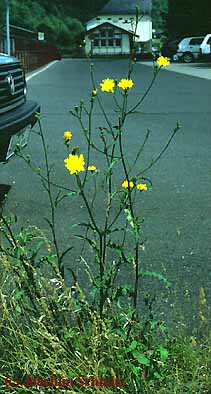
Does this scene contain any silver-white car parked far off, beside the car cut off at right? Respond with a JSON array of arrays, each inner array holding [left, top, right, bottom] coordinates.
[[176, 36, 204, 63]]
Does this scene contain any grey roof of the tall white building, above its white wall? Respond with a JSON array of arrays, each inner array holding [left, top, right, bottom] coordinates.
[[99, 0, 152, 15]]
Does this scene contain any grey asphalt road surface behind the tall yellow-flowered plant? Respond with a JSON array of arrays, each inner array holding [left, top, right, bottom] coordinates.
[[0, 59, 211, 332]]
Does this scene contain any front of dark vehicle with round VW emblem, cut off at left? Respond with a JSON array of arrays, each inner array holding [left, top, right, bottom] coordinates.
[[0, 53, 40, 163]]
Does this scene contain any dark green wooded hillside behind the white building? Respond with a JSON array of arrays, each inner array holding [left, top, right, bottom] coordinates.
[[0, 0, 168, 49]]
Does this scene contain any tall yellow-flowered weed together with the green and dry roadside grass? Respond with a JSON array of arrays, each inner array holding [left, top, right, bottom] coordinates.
[[0, 13, 211, 394]]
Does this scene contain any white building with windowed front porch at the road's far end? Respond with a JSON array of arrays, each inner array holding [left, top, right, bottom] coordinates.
[[85, 0, 152, 55]]
